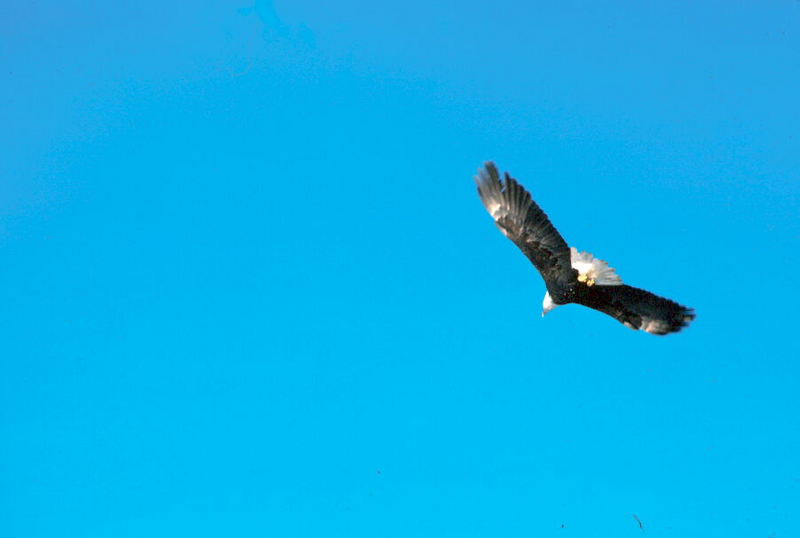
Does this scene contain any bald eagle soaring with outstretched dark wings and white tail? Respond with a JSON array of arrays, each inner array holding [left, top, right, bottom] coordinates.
[[475, 162, 694, 335]]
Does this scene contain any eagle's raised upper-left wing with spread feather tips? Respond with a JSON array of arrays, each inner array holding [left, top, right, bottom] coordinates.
[[475, 162, 576, 282]]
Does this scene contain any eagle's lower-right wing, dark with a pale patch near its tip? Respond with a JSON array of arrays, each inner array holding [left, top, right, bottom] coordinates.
[[575, 285, 694, 335]]
